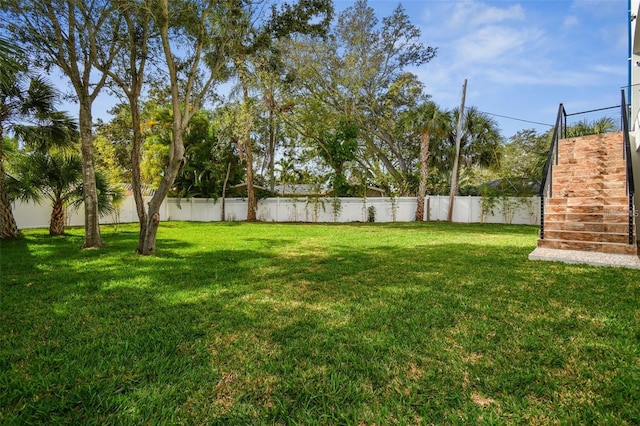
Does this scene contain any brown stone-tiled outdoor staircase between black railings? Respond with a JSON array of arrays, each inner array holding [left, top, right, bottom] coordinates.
[[538, 132, 637, 255]]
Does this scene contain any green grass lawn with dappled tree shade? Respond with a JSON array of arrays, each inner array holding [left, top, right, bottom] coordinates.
[[0, 222, 640, 425]]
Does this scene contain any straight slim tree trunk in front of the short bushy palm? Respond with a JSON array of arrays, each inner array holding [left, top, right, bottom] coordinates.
[[79, 95, 104, 249]]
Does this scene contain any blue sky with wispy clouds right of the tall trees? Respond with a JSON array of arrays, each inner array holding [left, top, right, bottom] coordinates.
[[335, 0, 628, 137]]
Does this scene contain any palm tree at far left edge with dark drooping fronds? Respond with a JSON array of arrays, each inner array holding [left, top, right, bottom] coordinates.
[[0, 40, 77, 238]]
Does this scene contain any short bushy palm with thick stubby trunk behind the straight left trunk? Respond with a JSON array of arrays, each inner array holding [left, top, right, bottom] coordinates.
[[9, 150, 123, 235]]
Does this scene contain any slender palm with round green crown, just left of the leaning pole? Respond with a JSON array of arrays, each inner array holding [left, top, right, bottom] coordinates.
[[403, 101, 451, 222]]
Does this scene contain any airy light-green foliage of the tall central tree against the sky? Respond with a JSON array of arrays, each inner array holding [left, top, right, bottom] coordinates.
[[288, 0, 436, 192]]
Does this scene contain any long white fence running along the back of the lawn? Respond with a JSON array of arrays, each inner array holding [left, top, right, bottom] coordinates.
[[13, 196, 540, 229]]
